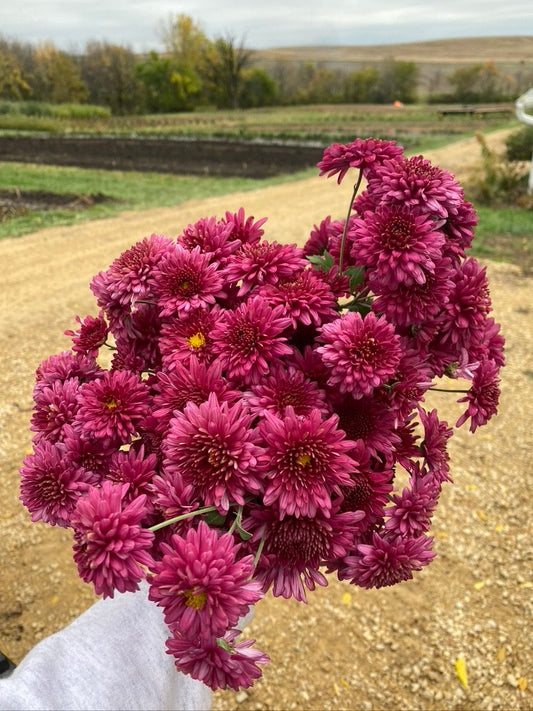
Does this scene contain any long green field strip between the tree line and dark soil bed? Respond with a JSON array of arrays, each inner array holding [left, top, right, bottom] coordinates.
[[0, 104, 511, 150]]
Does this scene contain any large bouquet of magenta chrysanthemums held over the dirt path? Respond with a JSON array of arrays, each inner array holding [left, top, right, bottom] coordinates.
[[21, 139, 504, 689]]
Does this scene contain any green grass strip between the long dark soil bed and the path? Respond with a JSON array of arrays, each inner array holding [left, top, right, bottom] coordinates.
[[0, 163, 316, 239]]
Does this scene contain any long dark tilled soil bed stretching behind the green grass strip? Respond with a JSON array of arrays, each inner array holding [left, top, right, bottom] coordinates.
[[0, 136, 323, 179]]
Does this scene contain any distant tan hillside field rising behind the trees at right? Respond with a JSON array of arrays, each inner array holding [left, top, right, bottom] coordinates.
[[253, 35, 533, 93]]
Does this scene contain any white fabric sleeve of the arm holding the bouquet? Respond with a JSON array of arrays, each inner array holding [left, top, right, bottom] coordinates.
[[0, 586, 211, 711]]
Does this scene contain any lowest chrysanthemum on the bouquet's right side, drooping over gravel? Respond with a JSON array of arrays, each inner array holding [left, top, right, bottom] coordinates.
[[339, 533, 435, 588]]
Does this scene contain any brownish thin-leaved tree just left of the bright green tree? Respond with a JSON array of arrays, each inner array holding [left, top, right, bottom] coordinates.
[[80, 42, 142, 114]]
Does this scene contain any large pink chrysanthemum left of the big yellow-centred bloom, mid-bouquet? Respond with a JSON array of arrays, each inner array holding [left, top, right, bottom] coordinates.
[[164, 393, 263, 513]]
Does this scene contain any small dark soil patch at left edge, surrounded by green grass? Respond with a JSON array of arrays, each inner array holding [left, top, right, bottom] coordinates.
[[0, 190, 112, 222]]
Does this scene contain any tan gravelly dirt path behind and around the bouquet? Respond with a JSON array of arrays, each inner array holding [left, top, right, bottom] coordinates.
[[0, 132, 533, 710]]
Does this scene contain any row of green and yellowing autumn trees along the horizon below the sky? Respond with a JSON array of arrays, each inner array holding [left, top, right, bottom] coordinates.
[[0, 14, 524, 114]]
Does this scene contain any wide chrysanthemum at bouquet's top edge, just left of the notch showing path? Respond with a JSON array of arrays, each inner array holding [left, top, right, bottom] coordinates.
[[222, 241, 307, 296]]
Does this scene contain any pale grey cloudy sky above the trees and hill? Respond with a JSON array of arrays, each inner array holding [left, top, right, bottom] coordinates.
[[0, 0, 533, 52]]
